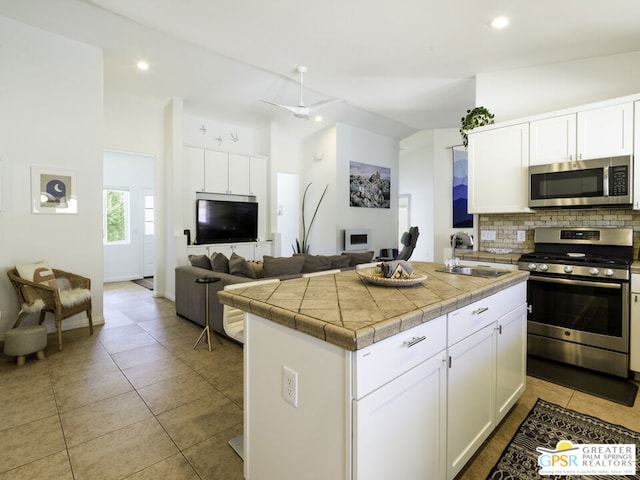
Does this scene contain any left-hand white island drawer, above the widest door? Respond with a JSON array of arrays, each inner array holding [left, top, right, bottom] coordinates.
[[352, 315, 447, 399]]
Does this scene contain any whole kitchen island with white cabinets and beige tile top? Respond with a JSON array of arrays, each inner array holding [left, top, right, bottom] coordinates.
[[219, 262, 528, 480]]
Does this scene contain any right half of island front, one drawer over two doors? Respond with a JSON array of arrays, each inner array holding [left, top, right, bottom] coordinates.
[[447, 283, 526, 479]]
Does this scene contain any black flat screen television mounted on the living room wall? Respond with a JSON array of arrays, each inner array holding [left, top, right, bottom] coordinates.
[[196, 199, 258, 244]]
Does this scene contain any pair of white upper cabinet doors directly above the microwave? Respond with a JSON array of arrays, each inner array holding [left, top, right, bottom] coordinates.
[[529, 102, 633, 165]]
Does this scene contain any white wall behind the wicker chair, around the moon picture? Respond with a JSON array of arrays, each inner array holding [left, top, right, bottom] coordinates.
[[0, 17, 103, 332]]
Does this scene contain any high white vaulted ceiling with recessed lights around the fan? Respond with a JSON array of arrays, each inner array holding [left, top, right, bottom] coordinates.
[[0, 0, 640, 138]]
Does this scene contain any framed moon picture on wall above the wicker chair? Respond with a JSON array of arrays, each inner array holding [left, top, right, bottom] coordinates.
[[31, 166, 78, 214]]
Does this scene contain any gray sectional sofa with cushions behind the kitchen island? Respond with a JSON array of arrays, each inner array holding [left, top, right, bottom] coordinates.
[[175, 251, 373, 336]]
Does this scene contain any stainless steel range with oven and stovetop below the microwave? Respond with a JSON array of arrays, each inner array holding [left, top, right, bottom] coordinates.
[[519, 227, 633, 377]]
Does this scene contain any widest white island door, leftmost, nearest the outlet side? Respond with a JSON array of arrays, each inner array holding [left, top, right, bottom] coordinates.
[[353, 352, 446, 480]]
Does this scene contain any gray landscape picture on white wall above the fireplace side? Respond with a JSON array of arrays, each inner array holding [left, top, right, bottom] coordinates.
[[349, 162, 391, 208]]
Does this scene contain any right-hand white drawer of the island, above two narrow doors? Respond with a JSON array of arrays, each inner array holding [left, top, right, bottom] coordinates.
[[447, 282, 527, 345]]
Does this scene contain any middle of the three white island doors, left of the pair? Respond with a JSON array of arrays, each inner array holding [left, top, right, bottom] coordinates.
[[447, 322, 497, 479]]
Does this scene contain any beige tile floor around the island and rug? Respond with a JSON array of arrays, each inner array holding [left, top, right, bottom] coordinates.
[[0, 282, 640, 480]]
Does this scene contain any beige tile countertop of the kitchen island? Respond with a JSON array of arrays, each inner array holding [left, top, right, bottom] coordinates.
[[218, 262, 529, 351]]
